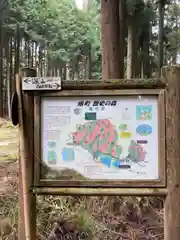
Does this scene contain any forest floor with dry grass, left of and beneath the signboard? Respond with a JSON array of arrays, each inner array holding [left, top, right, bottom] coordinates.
[[0, 119, 164, 240]]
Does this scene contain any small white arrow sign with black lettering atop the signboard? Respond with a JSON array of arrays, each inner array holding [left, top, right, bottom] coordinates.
[[22, 77, 61, 91]]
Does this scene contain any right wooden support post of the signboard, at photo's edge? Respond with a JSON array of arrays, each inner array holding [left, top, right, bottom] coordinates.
[[162, 66, 180, 240]]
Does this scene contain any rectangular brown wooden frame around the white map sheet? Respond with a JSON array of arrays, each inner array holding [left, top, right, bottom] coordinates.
[[34, 85, 166, 189]]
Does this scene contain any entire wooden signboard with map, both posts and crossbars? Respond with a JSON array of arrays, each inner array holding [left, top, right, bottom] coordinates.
[[12, 63, 180, 240]]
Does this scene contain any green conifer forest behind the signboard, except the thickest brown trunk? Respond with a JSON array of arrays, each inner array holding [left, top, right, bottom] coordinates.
[[0, 0, 180, 117]]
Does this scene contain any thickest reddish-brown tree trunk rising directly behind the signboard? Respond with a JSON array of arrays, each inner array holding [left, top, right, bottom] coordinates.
[[101, 0, 121, 79]]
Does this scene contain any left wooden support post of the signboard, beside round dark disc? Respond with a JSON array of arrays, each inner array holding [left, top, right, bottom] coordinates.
[[16, 68, 36, 240]]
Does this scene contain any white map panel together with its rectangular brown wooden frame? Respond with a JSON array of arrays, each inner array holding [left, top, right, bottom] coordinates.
[[34, 89, 165, 187]]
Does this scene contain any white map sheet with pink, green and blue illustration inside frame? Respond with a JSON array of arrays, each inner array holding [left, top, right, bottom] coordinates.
[[41, 96, 158, 180]]
